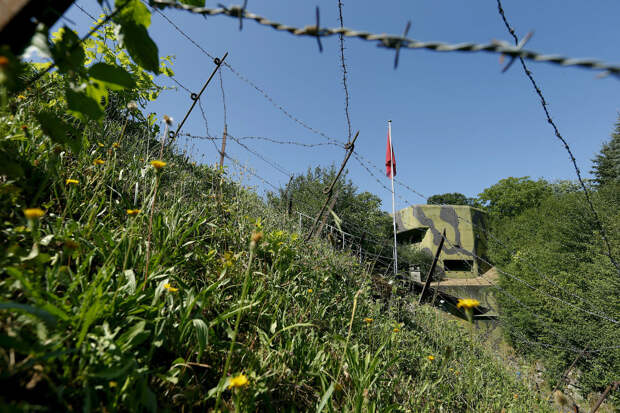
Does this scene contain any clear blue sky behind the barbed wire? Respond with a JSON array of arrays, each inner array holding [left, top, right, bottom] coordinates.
[[59, 0, 620, 210]]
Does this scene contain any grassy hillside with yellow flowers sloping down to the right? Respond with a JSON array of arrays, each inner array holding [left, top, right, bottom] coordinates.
[[0, 83, 549, 412]]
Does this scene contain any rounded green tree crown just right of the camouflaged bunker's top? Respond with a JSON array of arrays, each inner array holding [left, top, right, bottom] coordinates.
[[478, 176, 553, 219]]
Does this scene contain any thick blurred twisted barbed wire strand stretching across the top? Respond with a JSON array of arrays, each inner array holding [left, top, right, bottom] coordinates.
[[153, 0, 620, 77]]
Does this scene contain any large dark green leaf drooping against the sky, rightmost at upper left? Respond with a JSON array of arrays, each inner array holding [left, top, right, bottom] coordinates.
[[119, 22, 159, 75]]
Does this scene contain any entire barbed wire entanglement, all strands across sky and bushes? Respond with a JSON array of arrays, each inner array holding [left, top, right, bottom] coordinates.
[[68, 0, 620, 378]]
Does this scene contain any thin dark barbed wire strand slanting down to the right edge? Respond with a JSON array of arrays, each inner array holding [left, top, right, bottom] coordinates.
[[497, 0, 620, 274]]
